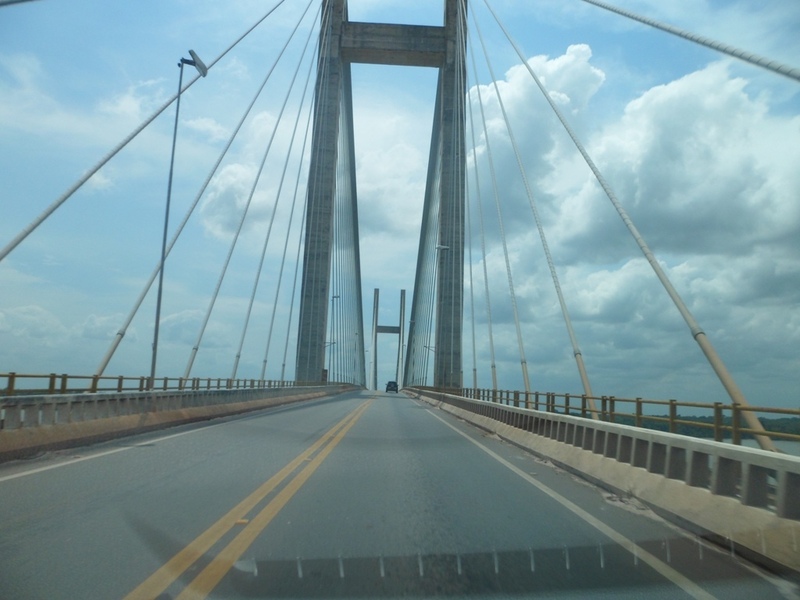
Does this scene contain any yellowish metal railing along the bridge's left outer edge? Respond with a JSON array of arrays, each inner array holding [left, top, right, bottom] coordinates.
[[0, 373, 308, 397]]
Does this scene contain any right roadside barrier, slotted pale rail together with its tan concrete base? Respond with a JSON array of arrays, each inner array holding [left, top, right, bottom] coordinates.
[[405, 388, 800, 576]]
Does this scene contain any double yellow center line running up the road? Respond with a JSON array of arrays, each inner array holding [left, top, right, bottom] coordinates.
[[124, 399, 372, 600]]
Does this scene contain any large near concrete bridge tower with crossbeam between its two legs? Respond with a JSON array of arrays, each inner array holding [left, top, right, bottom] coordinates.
[[295, 0, 466, 387]]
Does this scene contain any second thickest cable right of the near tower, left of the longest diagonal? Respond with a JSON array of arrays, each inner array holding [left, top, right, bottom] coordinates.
[[473, 9, 598, 412]]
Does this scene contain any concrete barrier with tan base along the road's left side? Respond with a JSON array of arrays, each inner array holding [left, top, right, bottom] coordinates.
[[0, 385, 354, 462]]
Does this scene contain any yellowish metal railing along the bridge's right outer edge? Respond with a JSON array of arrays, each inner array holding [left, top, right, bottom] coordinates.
[[438, 387, 800, 445]]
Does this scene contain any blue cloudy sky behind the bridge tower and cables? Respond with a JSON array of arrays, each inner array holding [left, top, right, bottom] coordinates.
[[0, 0, 800, 408]]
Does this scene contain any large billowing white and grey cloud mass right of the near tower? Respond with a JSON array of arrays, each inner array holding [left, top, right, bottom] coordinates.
[[466, 46, 800, 404]]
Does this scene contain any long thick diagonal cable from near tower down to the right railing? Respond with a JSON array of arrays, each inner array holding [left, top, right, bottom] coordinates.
[[484, 0, 776, 451]]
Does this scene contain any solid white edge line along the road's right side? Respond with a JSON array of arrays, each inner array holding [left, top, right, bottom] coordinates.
[[426, 409, 715, 600]]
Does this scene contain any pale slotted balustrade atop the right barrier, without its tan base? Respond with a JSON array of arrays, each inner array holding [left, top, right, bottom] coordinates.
[[411, 388, 800, 520]]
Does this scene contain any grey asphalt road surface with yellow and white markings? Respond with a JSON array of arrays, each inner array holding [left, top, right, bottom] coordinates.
[[0, 392, 797, 600]]
